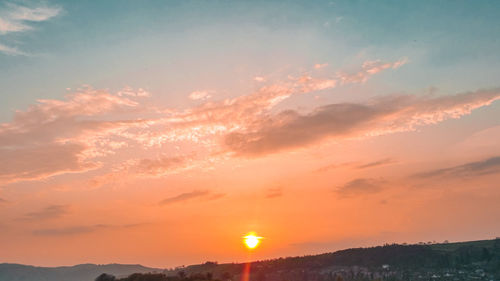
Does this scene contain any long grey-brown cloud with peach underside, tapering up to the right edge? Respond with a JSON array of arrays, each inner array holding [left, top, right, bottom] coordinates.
[[224, 89, 500, 156]]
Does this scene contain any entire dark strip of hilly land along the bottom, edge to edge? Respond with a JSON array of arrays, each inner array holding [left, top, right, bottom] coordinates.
[[0, 238, 500, 281]]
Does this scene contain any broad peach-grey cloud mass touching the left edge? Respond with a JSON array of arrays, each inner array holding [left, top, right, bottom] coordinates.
[[0, 89, 147, 183]]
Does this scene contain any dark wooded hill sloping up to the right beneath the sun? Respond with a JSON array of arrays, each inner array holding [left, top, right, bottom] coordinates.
[[167, 239, 500, 281]]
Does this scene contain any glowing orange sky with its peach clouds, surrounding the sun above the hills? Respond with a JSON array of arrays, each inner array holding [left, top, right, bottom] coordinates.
[[1, 66, 500, 267]]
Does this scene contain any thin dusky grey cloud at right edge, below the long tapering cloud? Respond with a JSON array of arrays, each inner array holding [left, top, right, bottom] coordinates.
[[413, 156, 500, 179]]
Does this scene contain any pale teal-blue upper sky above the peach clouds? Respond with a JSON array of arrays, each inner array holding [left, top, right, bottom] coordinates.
[[0, 1, 500, 121]]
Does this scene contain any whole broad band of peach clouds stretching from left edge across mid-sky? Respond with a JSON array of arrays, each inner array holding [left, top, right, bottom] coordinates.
[[0, 61, 450, 183]]
